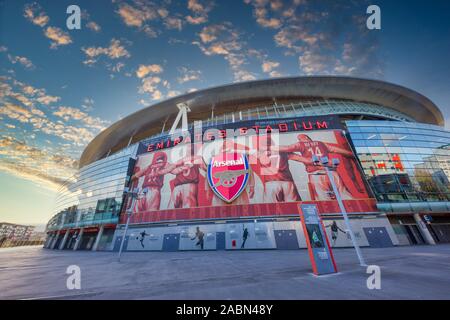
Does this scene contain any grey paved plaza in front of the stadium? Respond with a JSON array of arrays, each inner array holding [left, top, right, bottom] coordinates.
[[0, 245, 450, 299]]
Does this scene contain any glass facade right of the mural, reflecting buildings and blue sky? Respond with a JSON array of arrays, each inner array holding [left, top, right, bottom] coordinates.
[[346, 120, 450, 203]]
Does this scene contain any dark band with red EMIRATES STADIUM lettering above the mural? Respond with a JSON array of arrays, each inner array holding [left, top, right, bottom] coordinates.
[[140, 116, 342, 153]]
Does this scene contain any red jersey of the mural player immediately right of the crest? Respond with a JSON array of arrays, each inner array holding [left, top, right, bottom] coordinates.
[[258, 151, 294, 182]]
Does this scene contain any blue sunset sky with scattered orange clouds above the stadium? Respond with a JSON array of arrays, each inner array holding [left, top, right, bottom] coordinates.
[[0, 0, 450, 230]]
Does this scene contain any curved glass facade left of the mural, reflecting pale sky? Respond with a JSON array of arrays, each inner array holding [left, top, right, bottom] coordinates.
[[47, 144, 138, 230]]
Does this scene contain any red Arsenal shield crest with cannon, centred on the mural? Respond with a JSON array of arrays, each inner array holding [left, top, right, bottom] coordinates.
[[208, 152, 249, 203]]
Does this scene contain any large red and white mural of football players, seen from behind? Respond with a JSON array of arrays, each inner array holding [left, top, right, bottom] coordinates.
[[125, 130, 370, 216]]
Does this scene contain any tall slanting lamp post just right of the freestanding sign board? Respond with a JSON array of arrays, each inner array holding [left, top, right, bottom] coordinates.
[[312, 155, 367, 267]]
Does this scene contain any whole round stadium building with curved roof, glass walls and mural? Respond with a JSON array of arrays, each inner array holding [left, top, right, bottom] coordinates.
[[45, 76, 450, 251]]
